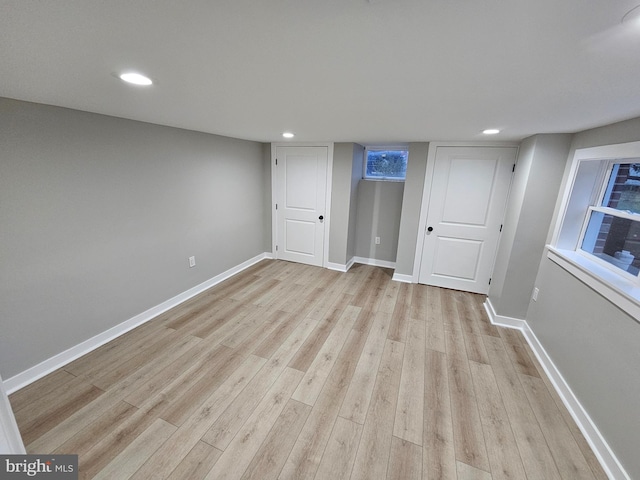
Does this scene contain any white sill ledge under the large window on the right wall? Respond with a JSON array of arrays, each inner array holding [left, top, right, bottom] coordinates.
[[547, 246, 640, 321]]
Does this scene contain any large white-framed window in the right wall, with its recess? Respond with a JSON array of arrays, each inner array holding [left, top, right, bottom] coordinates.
[[547, 142, 640, 321]]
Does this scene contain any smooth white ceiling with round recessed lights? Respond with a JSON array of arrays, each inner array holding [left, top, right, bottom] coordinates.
[[0, 0, 640, 143]]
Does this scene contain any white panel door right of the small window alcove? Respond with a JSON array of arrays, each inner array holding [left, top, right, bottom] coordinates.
[[418, 147, 517, 294]]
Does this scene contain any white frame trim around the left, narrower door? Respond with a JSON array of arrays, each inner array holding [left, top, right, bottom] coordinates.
[[271, 142, 334, 268]]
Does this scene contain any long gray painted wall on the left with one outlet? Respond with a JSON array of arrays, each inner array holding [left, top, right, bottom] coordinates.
[[0, 99, 270, 379]]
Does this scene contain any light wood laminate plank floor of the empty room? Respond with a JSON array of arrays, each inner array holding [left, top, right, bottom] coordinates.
[[10, 260, 606, 480]]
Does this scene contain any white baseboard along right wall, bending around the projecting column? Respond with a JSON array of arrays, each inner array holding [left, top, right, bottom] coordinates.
[[484, 298, 631, 480]]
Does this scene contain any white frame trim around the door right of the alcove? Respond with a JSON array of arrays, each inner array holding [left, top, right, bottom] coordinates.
[[411, 141, 520, 283]]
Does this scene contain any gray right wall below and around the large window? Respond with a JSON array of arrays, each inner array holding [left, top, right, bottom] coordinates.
[[526, 118, 640, 478]]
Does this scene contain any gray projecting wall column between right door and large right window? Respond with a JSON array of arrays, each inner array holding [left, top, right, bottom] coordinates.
[[489, 134, 572, 319]]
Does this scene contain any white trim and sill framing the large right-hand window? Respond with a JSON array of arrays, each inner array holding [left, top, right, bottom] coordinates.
[[547, 142, 640, 321]]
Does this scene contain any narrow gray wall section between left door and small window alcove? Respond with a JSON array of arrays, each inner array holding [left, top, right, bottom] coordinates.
[[329, 143, 363, 265]]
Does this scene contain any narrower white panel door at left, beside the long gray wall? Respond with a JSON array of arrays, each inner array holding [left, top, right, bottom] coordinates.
[[275, 147, 328, 266]]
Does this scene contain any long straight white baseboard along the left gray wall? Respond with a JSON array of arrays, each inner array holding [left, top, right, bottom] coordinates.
[[4, 253, 271, 394]]
